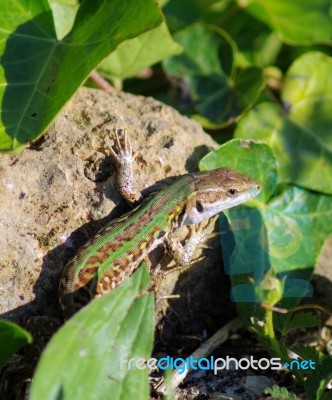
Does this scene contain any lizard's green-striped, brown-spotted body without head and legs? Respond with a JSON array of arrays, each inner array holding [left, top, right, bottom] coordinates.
[[59, 175, 195, 317]]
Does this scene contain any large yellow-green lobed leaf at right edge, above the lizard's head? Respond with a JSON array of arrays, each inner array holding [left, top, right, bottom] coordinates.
[[235, 52, 332, 194]]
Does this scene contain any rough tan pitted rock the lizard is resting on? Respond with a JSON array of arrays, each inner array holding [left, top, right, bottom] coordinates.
[[0, 88, 230, 344]]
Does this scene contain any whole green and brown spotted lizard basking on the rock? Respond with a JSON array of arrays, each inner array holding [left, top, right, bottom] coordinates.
[[59, 130, 261, 318]]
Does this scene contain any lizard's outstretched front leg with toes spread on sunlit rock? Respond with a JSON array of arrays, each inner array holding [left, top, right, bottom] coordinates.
[[109, 129, 142, 205]]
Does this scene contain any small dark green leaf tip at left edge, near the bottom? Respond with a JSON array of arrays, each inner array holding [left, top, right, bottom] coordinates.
[[0, 319, 32, 368]]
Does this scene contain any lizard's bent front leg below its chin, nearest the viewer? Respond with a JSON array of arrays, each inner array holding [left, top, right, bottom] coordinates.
[[165, 216, 218, 267]]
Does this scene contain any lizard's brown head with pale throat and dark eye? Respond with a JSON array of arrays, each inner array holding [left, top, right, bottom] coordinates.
[[184, 168, 261, 225]]
